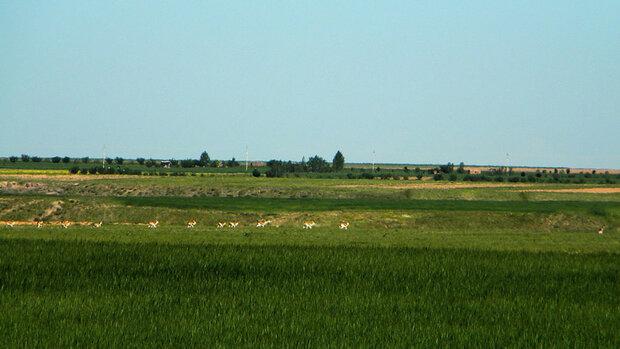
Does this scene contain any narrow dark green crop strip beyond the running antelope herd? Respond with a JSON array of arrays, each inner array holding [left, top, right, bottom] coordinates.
[[116, 196, 620, 216]]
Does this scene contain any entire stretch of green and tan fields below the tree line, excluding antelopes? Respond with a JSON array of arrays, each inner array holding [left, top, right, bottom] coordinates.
[[0, 174, 620, 347]]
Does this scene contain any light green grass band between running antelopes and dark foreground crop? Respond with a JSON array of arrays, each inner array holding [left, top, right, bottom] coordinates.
[[0, 225, 620, 251]]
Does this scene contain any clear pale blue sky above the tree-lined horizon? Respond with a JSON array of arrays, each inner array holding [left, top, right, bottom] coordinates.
[[0, 0, 620, 168]]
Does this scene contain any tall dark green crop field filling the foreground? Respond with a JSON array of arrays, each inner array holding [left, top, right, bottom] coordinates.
[[0, 240, 620, 347]]
